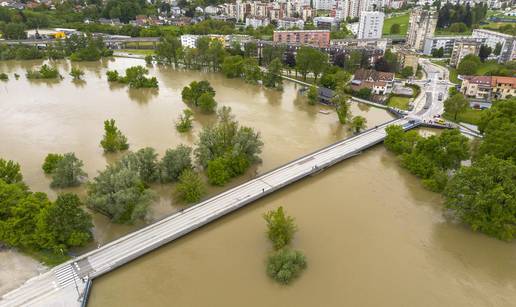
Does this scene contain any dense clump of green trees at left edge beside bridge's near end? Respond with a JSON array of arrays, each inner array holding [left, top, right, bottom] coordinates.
[[0, 159, 93, 264]]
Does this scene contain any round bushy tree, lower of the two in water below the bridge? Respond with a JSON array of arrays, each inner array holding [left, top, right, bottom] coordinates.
[[267, 248, 306, 284]]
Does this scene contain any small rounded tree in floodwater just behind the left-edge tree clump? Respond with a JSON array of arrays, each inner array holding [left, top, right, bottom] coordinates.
[[50, 152, 87, 188]]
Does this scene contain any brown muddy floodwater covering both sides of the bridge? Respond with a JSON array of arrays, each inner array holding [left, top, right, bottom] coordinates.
[[0, 59, 516, 306]]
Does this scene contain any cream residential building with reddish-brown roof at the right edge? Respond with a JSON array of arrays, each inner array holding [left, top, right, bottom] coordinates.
[[460, 76, 516, 100]]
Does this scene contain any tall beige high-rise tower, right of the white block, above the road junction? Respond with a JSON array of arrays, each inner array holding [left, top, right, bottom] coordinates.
[[406, 7, 437, 51]]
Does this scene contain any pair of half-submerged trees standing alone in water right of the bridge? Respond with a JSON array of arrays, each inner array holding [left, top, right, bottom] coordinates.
[[263, 207, 306, 284]]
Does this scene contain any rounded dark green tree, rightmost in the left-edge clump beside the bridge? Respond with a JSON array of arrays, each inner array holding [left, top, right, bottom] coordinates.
[[35, 193, 93, 253]]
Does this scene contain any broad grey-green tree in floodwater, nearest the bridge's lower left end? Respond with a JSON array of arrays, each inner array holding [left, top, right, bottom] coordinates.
[[86, 163, 156, 223]]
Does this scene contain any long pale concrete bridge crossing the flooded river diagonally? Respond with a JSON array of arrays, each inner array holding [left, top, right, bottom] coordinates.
[[0, 118, 419, 306]]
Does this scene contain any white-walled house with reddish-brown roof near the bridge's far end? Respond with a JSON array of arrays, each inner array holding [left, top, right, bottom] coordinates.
[[351, 69, 394, 95]]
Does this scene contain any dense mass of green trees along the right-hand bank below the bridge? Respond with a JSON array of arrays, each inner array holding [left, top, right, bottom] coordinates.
[[385, 99, 516, 241]]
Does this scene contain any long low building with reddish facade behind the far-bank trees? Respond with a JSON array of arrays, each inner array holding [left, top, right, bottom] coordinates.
[[273, 30, 330, 48]]
